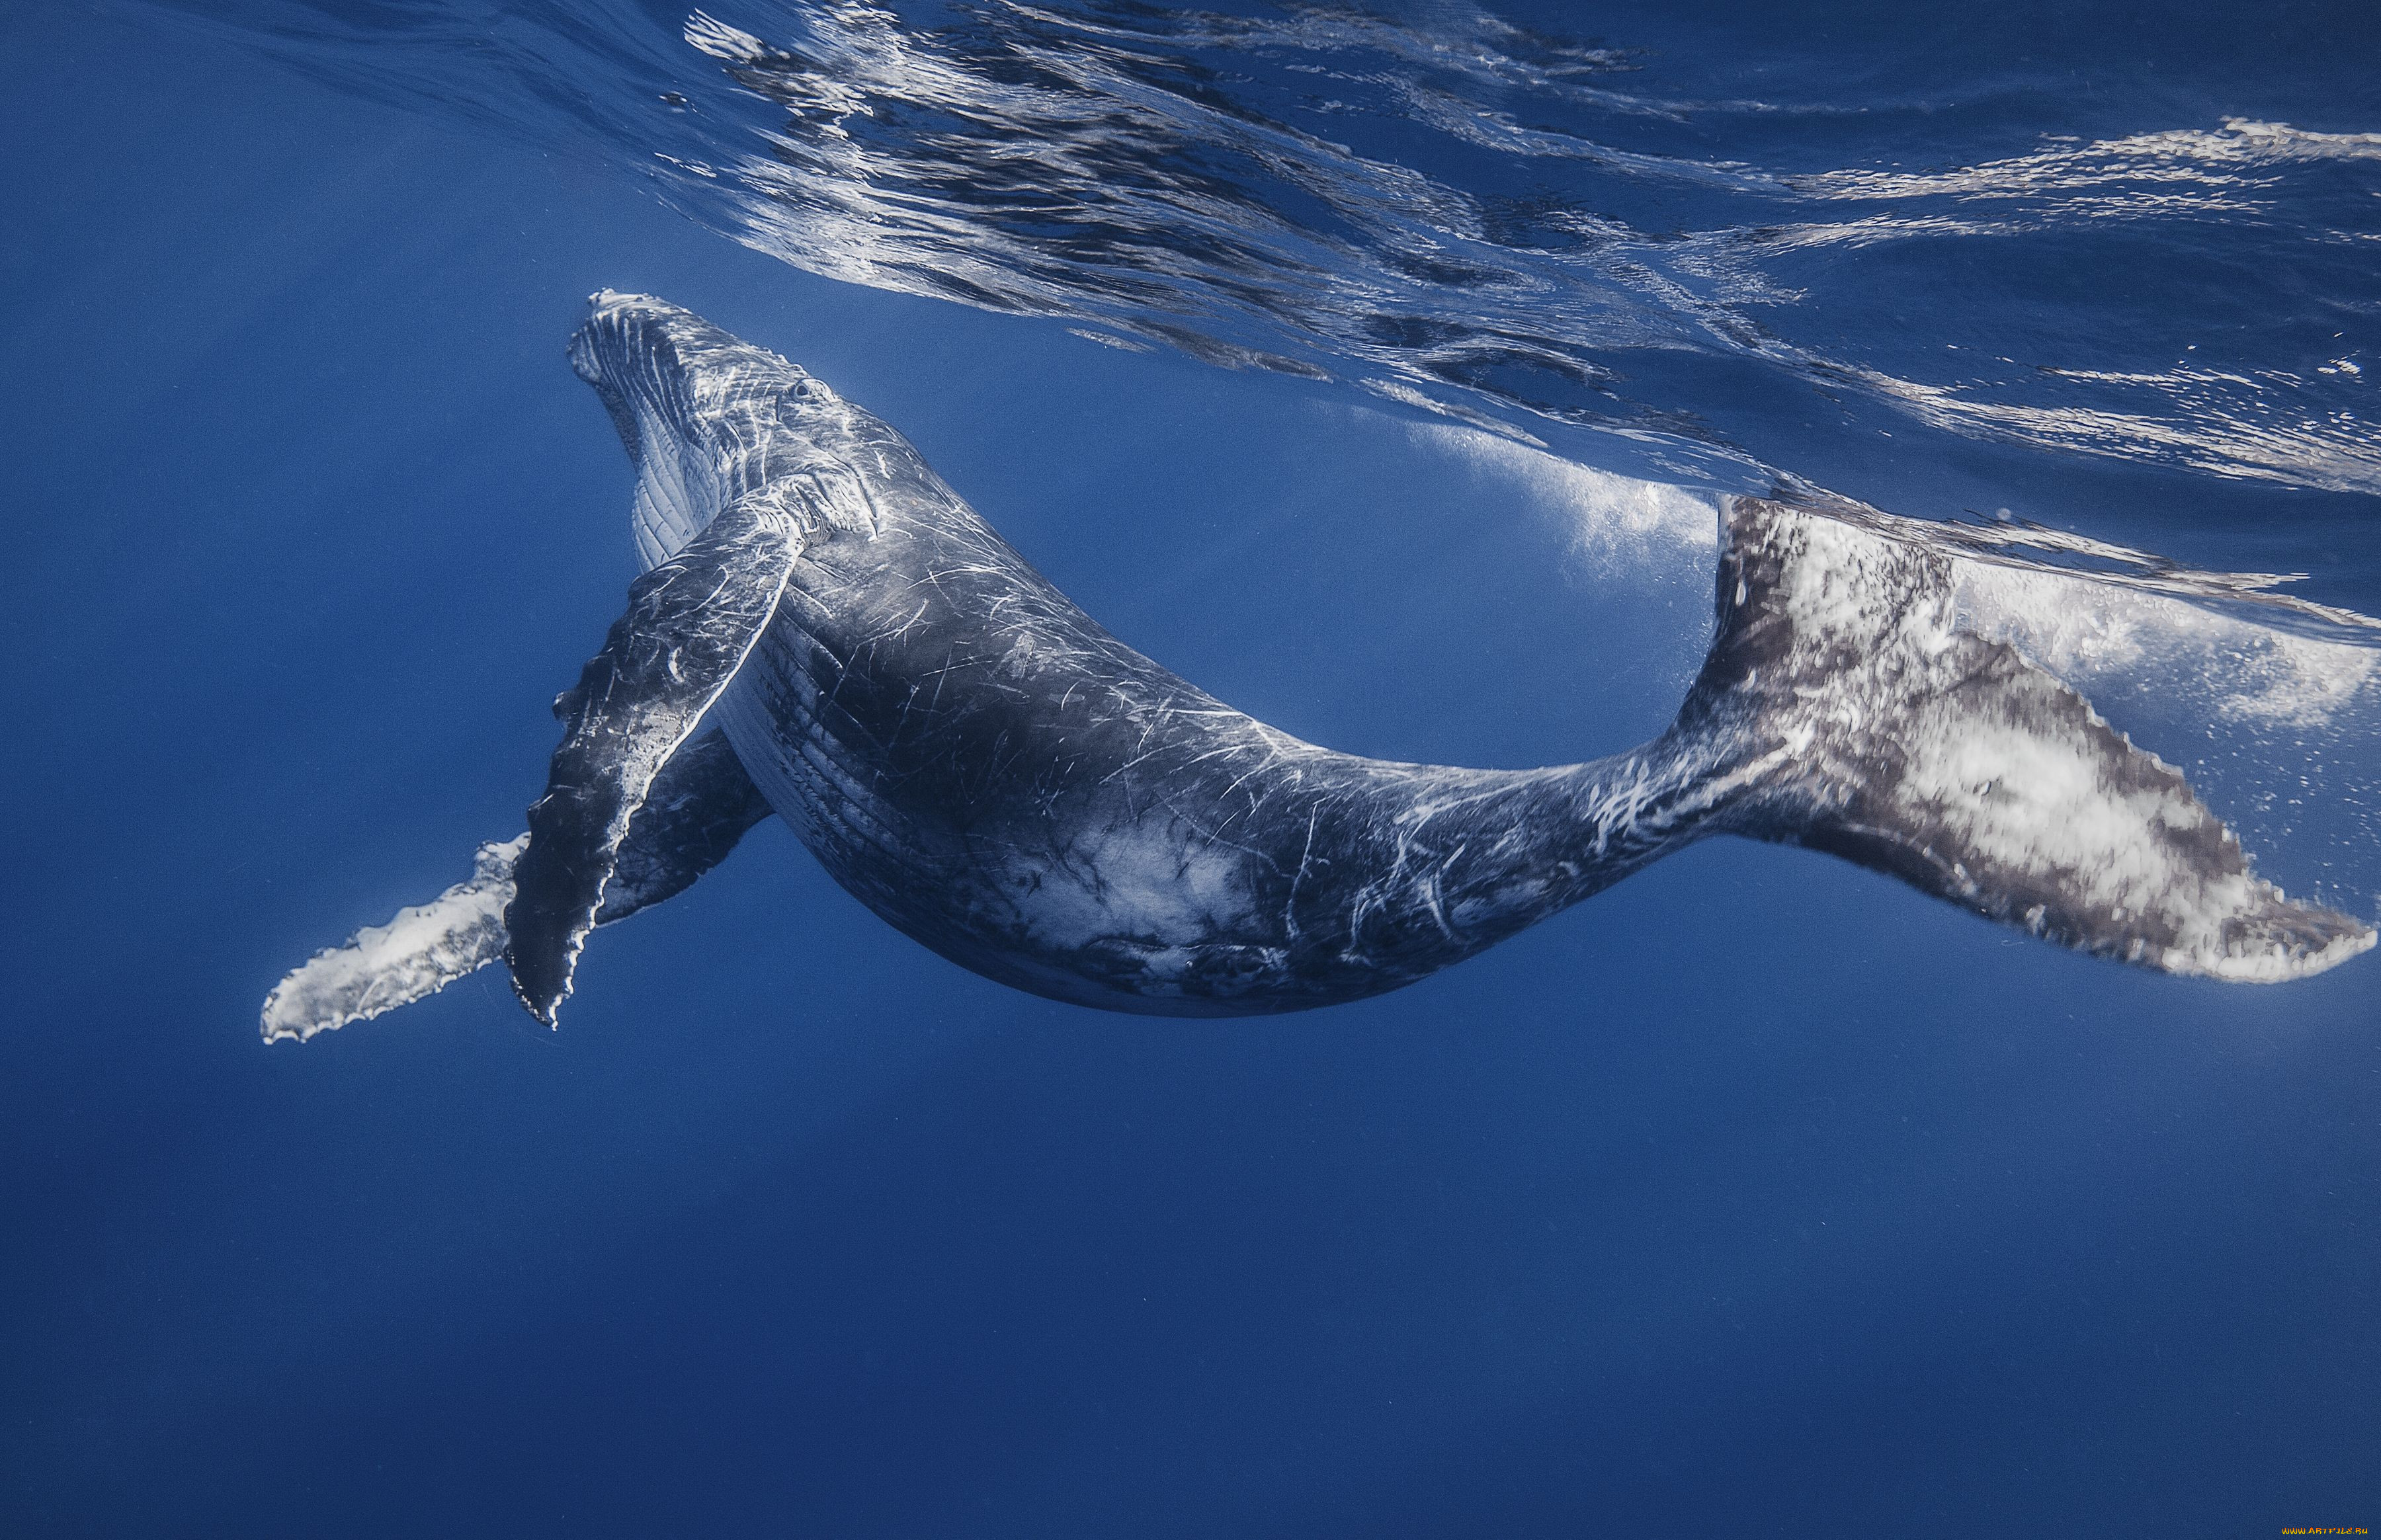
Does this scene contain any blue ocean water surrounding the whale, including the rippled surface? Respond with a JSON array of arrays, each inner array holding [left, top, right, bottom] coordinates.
[[0, 0, 2381, 1537]]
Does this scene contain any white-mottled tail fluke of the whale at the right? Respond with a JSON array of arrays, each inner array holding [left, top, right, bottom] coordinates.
[[1671, 497, 2374, 983]]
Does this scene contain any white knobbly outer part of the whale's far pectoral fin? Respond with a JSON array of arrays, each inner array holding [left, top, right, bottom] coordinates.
[[262, 833, 528, 1043]]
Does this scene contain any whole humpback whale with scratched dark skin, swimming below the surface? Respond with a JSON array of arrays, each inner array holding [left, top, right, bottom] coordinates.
[[262, 290, 2374, 1040]]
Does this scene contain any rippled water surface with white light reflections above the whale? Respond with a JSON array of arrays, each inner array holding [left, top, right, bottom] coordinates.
[[149, 3, 2381, 491]]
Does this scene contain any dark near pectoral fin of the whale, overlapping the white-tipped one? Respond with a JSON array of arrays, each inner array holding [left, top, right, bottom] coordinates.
[[503, 493, 802, 1026]]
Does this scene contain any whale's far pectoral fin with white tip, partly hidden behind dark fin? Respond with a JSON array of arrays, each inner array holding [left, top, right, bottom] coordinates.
[[262, 729, 769, 1043]]
